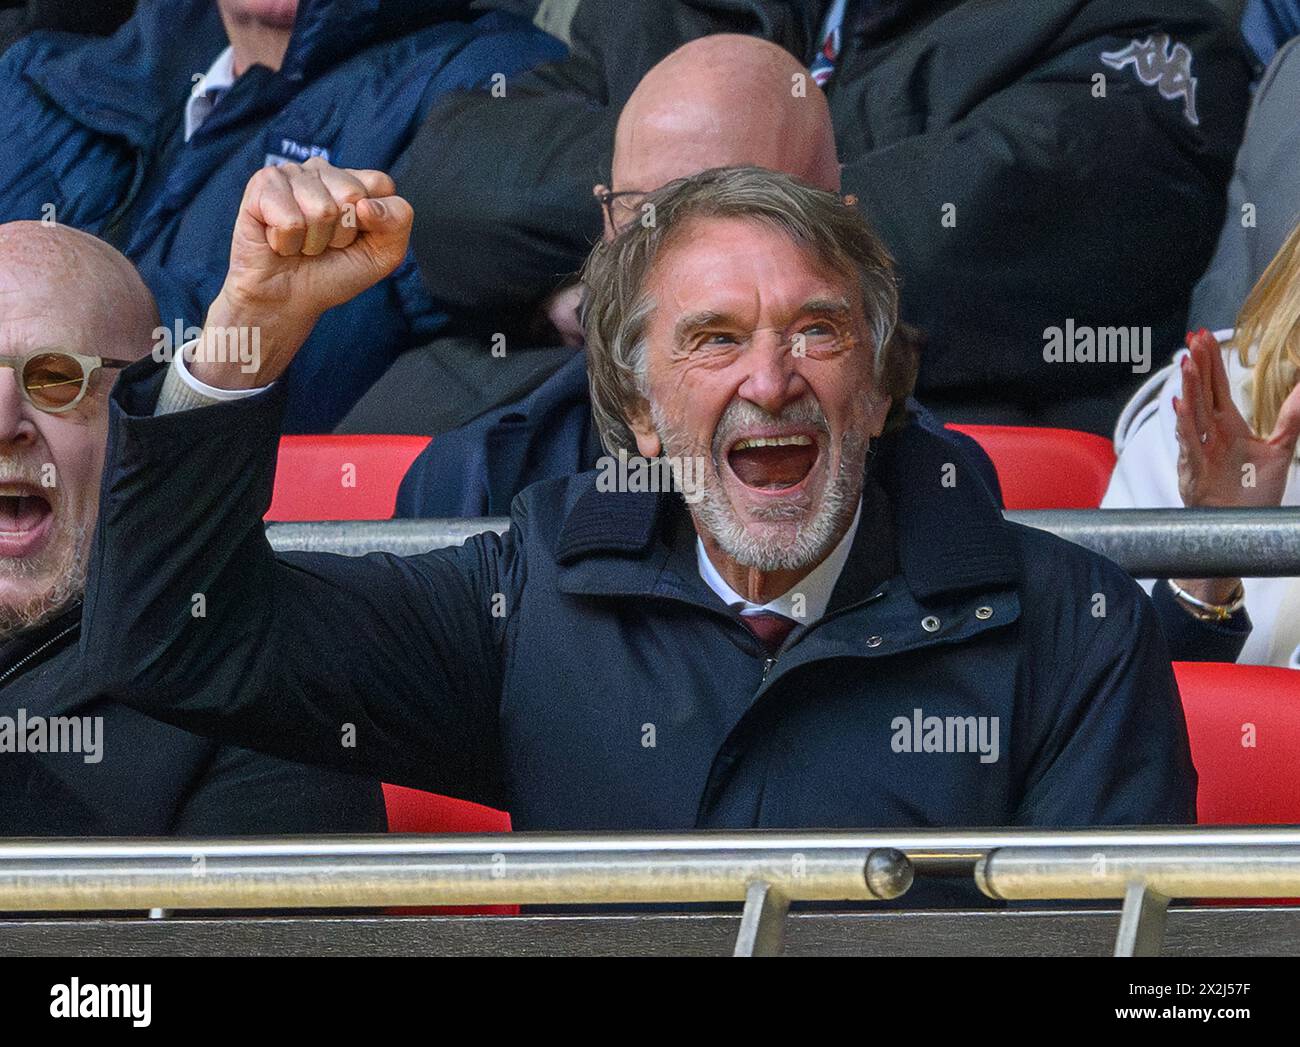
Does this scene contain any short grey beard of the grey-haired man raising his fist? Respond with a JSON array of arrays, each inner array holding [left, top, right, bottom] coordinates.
[[650, 403, 870, 572]]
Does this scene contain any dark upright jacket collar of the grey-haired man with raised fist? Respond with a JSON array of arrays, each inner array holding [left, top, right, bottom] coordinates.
[[555, 421, 1019, 607]]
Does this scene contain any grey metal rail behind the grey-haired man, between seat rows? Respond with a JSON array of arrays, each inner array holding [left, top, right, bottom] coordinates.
[[267, 509, 1300, 577]]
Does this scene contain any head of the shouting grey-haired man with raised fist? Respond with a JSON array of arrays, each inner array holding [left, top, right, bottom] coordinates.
[[584, 168, 911, 585]]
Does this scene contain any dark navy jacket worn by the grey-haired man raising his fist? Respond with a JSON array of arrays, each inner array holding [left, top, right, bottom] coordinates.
[[82, 362, 1196, 884]]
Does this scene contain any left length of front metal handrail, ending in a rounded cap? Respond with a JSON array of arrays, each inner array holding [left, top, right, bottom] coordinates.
[[0, 835, 913, 912]]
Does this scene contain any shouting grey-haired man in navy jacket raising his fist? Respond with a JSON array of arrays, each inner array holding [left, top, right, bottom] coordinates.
[[87, 160, 1196, 900]]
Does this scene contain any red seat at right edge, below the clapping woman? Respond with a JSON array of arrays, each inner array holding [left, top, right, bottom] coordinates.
[[1174, 662, 1300, 825]]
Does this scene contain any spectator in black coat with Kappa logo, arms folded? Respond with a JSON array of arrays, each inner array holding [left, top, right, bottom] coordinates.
[[398, 0, 1251, 432]]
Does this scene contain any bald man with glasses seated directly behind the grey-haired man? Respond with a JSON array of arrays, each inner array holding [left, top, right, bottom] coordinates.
[[384, 34, 997, 516]]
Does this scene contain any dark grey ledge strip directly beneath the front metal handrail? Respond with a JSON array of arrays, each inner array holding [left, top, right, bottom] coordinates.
[[0, 905, 1300, 957]]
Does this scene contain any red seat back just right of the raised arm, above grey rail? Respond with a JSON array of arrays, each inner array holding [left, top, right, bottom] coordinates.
[[267, 436, 429, 520]]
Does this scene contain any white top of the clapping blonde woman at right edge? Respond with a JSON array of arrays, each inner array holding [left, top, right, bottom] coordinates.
[[1101, 330, 1300, 669]]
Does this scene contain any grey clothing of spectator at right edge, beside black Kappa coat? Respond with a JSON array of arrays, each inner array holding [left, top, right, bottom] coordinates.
[[1188, 40, 1300, 330]]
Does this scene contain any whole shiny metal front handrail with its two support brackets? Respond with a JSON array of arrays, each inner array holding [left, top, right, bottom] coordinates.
[[0, 826, 1300, 956]]
